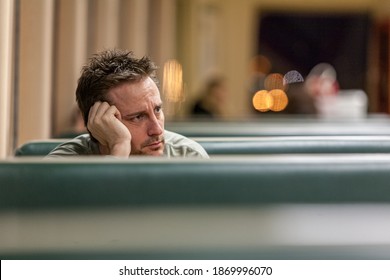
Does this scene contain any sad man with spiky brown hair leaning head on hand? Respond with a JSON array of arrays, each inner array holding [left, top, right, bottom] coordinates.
[[48, 50, 208, 158]]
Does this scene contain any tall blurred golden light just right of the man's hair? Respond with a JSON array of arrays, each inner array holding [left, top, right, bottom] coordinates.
[[163, 59, 184, 102]]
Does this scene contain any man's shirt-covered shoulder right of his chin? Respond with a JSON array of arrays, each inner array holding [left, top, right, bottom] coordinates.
[[164, 130, 209, 158]]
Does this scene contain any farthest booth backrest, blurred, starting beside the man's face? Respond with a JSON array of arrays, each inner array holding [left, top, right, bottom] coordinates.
[[165, 117, 390, 137]]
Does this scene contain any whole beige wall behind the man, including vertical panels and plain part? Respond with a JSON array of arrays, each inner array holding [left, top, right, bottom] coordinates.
[[6, 0, 390, 153]]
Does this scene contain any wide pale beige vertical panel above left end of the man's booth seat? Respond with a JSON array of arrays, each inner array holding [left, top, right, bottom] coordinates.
[[17, 0, 54, 145]]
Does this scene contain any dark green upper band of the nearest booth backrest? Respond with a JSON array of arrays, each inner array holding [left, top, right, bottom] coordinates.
[[0, 154, 390, 209]]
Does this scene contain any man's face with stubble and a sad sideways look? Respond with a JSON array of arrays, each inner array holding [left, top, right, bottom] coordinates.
[[107, 77, 164, 156]]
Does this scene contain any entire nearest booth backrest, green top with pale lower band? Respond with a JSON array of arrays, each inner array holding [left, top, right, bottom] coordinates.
[[0, 154, 390, 259]]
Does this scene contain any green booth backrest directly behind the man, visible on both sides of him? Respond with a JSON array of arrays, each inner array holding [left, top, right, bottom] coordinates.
[[15, 136, 390, 157]]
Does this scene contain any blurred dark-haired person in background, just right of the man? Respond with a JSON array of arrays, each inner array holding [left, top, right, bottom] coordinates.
[[191, 76, 227, 118]]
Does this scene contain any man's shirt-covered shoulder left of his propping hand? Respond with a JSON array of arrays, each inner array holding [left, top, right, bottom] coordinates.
[[47, 134, 99, 157]]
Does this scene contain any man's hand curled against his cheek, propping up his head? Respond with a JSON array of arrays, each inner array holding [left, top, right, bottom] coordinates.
[[87, 101, 131, 158]]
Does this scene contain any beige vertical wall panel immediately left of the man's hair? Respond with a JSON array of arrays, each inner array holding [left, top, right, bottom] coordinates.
[[53, 0, 88, 136]]
